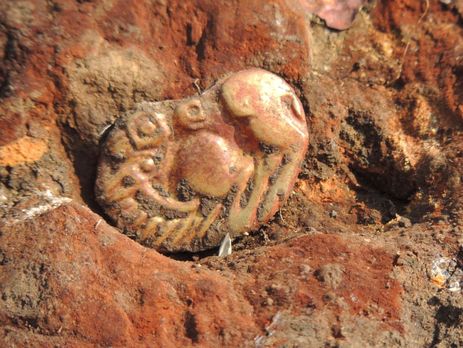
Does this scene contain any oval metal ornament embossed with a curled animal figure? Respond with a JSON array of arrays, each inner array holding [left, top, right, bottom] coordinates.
[[96, 69, 308, 252]]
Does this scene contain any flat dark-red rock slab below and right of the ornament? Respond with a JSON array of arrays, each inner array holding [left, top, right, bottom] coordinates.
[[205, 233, 402, 346]]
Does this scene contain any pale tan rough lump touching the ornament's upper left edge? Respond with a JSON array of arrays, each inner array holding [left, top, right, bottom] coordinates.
[[66, 44, 167, 145]]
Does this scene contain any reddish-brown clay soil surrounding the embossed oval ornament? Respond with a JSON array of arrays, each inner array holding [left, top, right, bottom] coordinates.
[[0, 0, 463, 347]]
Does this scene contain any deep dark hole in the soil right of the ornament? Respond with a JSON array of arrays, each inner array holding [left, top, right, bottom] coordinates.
[[339, 109, 418, 224]]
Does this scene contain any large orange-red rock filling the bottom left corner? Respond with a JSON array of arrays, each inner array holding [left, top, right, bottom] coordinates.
[[0, 203, 259, 347]]
